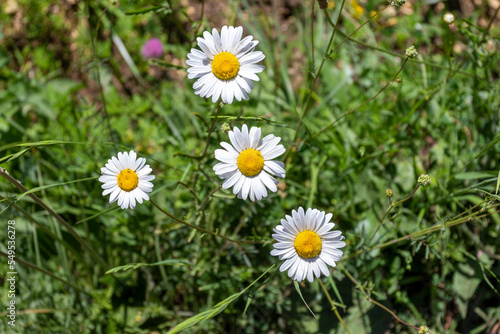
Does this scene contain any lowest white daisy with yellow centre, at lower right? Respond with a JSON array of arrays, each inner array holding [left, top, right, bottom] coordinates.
[[271, 207, 345, 282]]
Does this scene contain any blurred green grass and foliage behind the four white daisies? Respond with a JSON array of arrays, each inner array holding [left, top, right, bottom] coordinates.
[[0, 0, 500, 333]]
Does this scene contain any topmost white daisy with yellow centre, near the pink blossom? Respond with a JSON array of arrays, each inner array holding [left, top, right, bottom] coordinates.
[[186, 26, 265, 104]]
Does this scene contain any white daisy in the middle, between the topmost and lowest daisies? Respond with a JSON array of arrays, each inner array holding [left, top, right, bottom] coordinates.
[[214, 124, 286, 202]]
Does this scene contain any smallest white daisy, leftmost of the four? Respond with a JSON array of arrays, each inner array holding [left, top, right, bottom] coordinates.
[[99, 151, 155, 209]]
